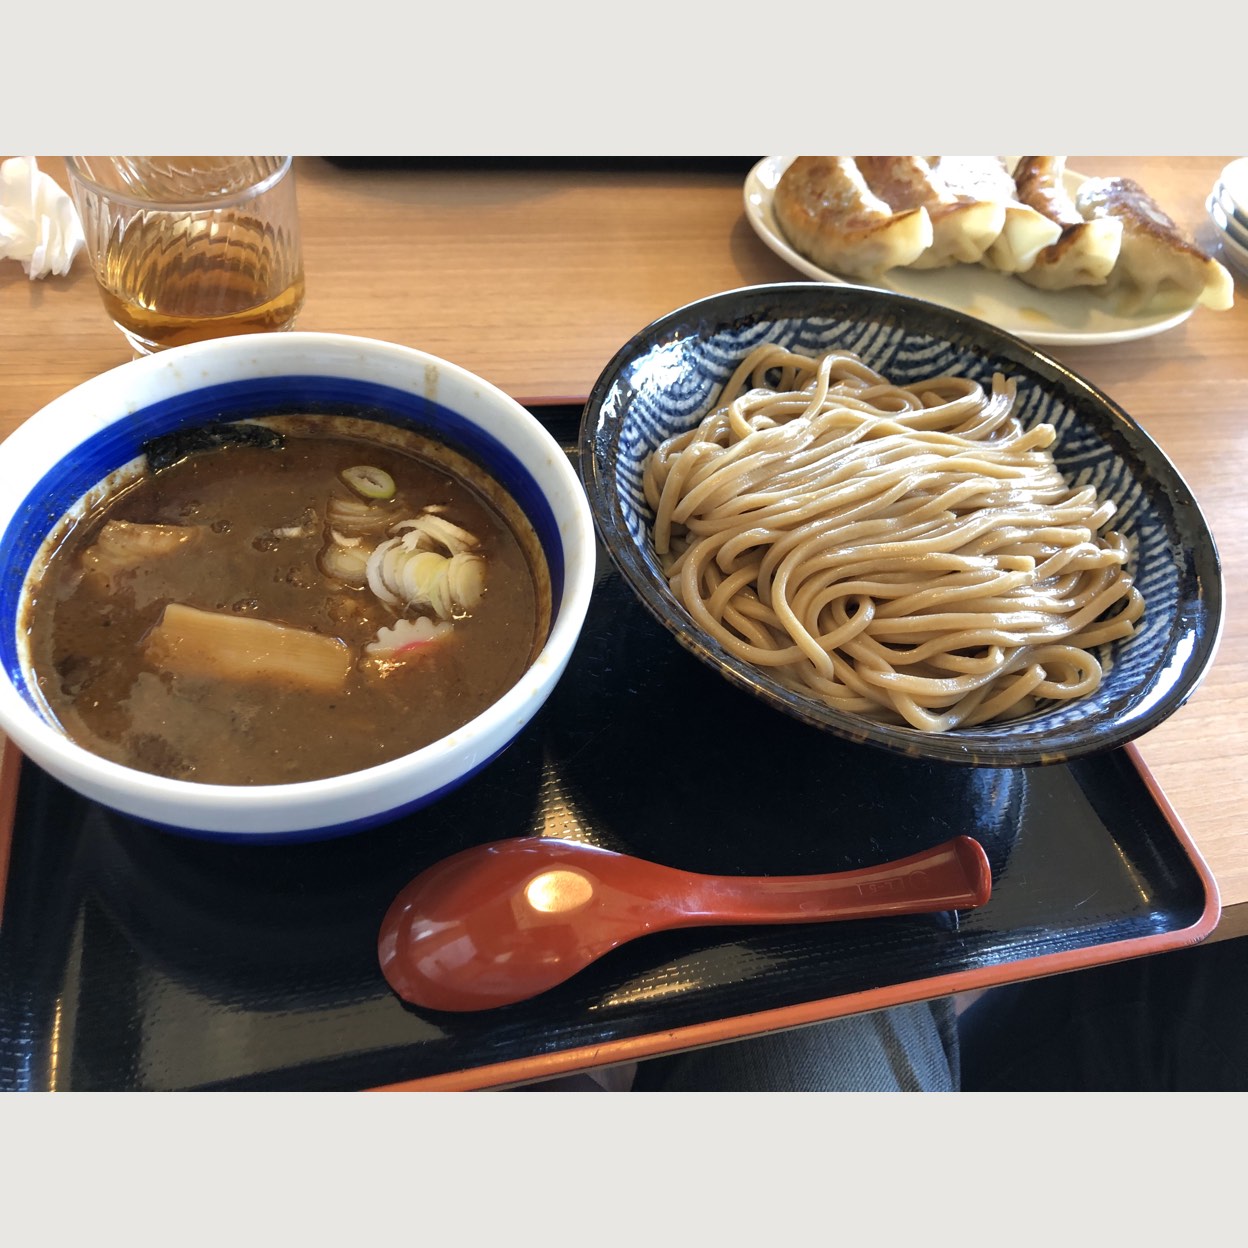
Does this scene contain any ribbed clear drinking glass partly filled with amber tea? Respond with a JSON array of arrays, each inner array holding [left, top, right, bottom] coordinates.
[[65, 156, 303, 356]]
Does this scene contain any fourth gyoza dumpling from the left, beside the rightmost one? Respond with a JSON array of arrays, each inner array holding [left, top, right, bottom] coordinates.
[[1013, 156, 1122, 291]]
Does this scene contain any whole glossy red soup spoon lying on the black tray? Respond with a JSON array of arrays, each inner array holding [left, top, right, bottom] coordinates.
[[377, 836, 992, 1011]]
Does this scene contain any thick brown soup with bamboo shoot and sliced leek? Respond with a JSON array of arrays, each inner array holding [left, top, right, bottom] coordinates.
[[27, 424, 549, 785]]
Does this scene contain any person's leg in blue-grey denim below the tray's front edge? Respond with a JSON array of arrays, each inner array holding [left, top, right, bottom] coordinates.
[[633, 997, 958, 1092]]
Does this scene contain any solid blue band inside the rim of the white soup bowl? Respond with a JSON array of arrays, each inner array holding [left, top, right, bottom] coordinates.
[[0, 376, 564, 711]]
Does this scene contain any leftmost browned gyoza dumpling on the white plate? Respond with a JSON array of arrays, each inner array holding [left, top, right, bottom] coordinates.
[[771, 156, 932, 282]]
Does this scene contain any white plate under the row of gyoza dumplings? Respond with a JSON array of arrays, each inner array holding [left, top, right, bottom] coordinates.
[[745, 156, 1192, 347]]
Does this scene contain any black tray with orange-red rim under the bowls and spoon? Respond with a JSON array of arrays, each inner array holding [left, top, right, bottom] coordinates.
[[0, 408, 1218, 1090]]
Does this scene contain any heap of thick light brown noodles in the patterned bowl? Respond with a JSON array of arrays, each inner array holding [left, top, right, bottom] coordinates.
[[643, 346, 1144, 731]]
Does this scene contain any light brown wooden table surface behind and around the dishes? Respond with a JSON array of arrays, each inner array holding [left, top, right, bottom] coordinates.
[[0, 156, 1248, 938]]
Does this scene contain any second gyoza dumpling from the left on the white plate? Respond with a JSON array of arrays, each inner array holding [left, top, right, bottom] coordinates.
[[855, 156, 1006, 268]]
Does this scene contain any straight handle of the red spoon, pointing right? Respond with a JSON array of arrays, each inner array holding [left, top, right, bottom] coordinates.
[[680, 836, 992, 926]]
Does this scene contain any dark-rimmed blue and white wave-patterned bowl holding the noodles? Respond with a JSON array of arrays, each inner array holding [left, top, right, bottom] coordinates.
[[579, 283, 1223, 766]]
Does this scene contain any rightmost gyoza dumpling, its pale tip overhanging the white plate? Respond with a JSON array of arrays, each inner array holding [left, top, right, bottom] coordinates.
[[1075, 177, 1234, 314]]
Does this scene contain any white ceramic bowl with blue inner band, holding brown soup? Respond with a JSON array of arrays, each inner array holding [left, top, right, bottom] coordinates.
[[0, 332, 595, 841]]
